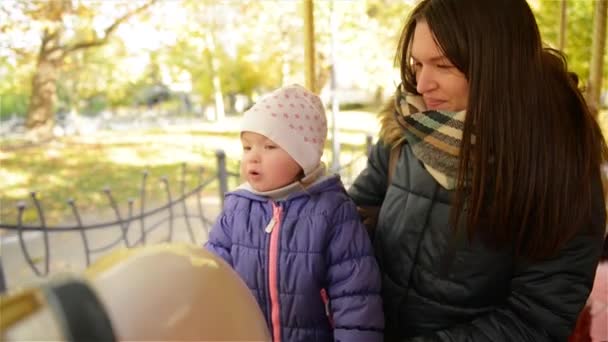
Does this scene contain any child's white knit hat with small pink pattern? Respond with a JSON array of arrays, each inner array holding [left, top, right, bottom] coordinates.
[[241, 84, 327, 175]]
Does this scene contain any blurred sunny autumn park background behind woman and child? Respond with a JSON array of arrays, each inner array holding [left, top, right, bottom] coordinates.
[[0, 0, 608, 288]]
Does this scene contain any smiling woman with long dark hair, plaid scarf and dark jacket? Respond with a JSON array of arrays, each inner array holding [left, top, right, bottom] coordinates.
[[349, 0, 607, 341]]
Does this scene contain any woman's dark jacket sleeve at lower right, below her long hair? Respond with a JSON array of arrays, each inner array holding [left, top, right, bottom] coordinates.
[[405, 175, 606, 342]]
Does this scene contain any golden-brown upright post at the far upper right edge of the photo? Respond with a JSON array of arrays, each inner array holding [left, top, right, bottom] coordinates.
[[587, 0, 608, 116]]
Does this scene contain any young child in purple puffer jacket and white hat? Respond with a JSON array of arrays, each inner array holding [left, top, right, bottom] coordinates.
[[205, 85, 384, 342]]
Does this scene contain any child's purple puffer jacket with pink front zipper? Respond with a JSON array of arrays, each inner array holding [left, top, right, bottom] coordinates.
[[205, 176, 384, 342]]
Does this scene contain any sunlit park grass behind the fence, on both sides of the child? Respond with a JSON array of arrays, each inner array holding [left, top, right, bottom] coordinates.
[[0, 123, 364, 225]]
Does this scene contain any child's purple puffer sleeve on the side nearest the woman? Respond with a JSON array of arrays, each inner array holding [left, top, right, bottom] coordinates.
[[326, 200, 384, 342]]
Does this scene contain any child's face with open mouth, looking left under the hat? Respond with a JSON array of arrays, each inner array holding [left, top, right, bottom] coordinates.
[[241, 132, 302, 192]]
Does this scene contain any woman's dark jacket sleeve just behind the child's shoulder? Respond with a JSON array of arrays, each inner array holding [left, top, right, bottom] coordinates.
[[348, 140, 390, 206]]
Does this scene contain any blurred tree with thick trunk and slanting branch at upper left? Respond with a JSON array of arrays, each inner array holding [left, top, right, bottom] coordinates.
[[0, 0, 156, 139]]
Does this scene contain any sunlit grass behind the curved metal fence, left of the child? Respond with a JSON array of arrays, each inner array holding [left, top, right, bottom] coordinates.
[[0, 133, 242, 225]]
